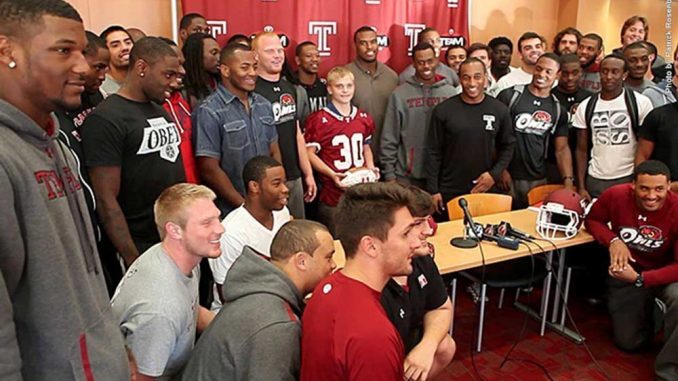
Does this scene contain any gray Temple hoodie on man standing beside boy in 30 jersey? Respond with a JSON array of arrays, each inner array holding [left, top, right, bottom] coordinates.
[[380, 76, 459, 180]]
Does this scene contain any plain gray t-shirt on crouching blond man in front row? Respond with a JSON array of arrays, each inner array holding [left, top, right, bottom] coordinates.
[[111, 243, 200, 380]]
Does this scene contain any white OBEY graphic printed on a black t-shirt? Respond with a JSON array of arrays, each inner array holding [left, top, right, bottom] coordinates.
[[137, 117, 181, 163]]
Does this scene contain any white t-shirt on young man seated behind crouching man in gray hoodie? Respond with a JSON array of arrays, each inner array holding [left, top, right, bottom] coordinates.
[[209, 205, 290, 310]]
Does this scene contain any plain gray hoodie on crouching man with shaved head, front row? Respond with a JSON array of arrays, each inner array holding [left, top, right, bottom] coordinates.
[[179, 246, 303, 381]]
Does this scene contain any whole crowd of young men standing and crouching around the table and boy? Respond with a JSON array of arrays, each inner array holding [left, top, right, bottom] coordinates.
[[0, 0, 678, 380]]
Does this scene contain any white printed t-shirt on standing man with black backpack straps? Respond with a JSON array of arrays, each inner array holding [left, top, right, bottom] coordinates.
[[572, 90, 652, 180]]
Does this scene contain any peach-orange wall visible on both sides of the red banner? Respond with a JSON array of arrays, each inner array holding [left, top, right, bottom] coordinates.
[[68, 0, 678, 64]]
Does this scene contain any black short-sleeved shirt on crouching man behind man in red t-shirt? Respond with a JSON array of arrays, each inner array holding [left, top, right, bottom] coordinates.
[[381, 255, 447, 353]]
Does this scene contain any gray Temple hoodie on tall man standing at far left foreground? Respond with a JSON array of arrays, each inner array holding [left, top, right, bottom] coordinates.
[[0, 100, 129, 381]]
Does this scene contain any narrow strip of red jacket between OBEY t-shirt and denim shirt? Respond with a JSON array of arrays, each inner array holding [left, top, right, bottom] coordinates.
[[162, 91, 200, 184]]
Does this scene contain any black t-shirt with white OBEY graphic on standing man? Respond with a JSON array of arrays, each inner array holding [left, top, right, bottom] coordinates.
[[82, 94, 186, 253]]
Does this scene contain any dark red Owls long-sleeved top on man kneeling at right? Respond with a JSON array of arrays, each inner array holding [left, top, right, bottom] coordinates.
[[586, 184, 678, 287]]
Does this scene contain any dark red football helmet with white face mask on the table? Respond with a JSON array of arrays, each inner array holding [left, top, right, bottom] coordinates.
[[536, 189, 586, 241]]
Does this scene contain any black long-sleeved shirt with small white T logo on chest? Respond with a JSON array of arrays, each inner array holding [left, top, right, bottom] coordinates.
[[426, 95, 515, 201]]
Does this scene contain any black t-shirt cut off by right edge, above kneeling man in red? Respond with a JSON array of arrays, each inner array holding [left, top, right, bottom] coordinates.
[[638, 103, 678, 181]]
